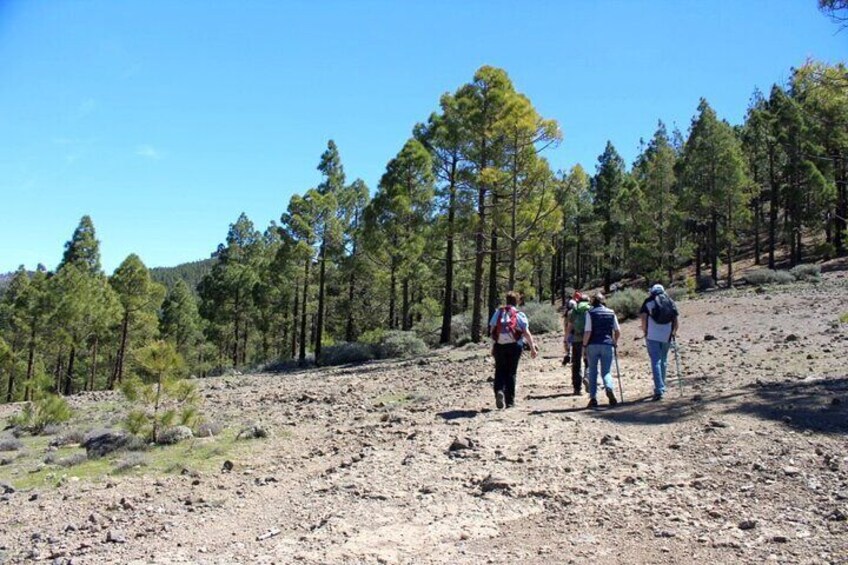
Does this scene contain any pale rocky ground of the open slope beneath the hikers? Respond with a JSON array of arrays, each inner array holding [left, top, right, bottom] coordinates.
[[0, 272, 848, 564]]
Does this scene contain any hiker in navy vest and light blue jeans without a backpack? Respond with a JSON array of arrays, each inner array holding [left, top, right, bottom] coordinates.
[[583, 292, 621, 408]]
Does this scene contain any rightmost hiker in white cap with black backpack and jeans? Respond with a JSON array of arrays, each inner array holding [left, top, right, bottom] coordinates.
[[639, 284, 678, 401]]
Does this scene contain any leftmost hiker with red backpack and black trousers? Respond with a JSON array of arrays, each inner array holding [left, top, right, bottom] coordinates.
[[489, 290, 538, 408]]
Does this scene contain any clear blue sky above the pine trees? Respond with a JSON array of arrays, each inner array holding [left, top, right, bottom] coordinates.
[[0, 0, 848, 272]]
